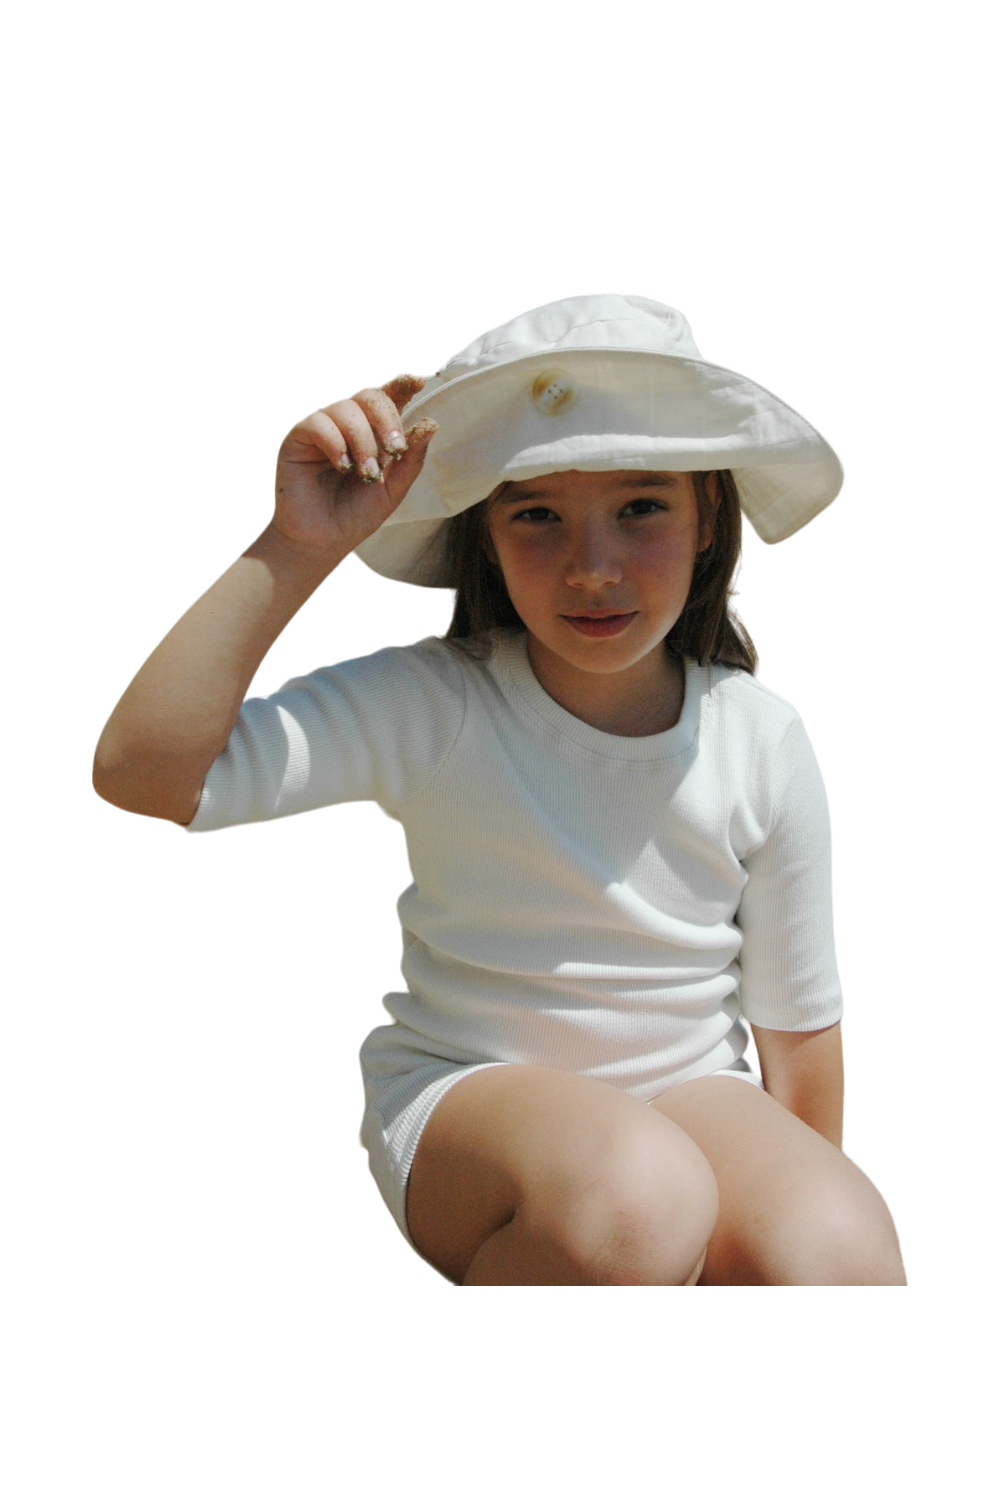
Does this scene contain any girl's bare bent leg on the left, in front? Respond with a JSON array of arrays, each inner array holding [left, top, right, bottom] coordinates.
[[406, 1066, 719, 1286]]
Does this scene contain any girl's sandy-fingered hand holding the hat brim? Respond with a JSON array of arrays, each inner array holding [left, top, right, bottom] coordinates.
[[271, 374, 438, 558]]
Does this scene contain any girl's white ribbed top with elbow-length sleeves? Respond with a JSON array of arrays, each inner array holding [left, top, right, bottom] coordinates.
[[188, 633, 844, 1101]]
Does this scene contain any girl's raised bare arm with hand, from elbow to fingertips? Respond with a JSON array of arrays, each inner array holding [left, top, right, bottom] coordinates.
[[93, 376, 436, 826]]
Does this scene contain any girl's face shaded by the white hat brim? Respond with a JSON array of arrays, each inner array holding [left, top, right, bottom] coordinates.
[[487, 471, 711, 727]]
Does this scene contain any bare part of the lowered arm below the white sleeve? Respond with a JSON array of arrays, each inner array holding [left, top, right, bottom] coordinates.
[[752, 1024, 847, 1149]]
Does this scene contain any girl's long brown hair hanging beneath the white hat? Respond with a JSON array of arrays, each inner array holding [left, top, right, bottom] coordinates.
[[444, 471, 761, 677]]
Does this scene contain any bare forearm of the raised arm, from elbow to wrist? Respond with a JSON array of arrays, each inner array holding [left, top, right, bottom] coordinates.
[[93, 523, 343, 824]]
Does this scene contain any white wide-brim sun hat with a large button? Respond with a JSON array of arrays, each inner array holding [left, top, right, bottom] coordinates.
[[355, 292, 844, 587]]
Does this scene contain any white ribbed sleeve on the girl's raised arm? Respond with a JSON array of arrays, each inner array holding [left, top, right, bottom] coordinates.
[[185, 639, 465, 835]]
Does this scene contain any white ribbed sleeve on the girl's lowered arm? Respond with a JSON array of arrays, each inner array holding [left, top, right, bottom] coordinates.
[[737, 714, 844, 1032]]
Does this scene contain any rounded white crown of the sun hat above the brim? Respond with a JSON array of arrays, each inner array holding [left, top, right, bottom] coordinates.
[[435, 292, 704, 382]]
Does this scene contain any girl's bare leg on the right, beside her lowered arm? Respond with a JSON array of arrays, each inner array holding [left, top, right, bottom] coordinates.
[[651, 1077, 907, 1284]]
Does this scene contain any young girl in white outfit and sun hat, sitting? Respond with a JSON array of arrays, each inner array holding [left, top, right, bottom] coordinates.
[[93, 293, 907, 1286]]
